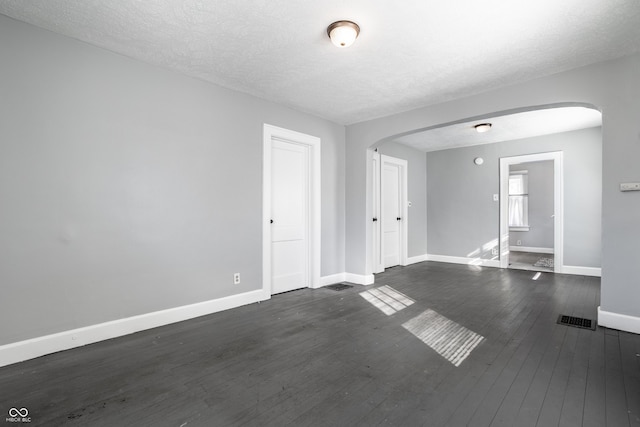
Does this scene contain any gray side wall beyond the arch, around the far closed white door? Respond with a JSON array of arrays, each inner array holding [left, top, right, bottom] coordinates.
[[378, 142, 427, 257]]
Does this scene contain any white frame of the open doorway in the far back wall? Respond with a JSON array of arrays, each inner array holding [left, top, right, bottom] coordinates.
[[500, 151, 564, 273]]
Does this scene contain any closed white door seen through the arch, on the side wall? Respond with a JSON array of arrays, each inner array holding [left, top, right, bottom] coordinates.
[[381, 160, 402, 268]]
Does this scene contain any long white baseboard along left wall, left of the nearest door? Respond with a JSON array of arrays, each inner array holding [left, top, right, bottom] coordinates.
[[0, 289, 271, 366]]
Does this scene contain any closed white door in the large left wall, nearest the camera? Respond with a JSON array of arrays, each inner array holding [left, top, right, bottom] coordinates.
[[271, 140, 310, 294]]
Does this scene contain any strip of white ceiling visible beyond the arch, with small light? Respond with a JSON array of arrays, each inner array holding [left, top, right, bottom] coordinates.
[[394, 107, 602, 151]]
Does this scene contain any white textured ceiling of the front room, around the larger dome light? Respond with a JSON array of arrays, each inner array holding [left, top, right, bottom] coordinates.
[[0, 0, 640, 124]]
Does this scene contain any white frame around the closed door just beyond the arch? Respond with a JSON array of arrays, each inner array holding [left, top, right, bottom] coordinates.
[[371, 152, 409, 273]]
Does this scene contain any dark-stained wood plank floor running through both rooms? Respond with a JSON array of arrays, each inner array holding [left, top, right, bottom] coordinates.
[[0, 262, 640, 427]]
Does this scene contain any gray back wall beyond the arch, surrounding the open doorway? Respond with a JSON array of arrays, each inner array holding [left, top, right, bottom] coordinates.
[[427, 128, 602, 267]]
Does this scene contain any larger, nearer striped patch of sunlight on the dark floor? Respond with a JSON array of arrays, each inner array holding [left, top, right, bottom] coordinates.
[[402, 310, 484, 367]]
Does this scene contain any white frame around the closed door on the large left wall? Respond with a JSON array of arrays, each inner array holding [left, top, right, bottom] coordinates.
[[262, 123, 321, 298]]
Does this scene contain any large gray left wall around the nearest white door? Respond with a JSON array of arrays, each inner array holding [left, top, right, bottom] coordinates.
[[0, 15, 345, 345]]
